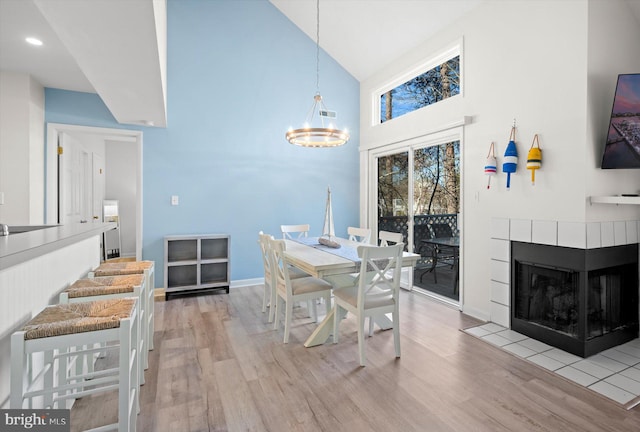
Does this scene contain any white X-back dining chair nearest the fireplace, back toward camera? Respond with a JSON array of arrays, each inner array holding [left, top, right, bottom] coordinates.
[[333, 243, 404, 366]]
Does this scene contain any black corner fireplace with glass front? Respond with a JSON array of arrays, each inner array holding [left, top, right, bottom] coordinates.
[[511, 242, 638, 357]]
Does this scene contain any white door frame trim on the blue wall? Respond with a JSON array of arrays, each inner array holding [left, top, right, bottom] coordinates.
[[45, 123, 143, 260]]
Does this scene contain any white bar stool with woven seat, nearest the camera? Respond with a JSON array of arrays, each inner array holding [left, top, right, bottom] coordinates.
[[10, 298, 139, 432]]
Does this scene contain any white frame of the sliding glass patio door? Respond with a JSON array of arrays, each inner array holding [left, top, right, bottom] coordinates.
[[363, 125, 465, 310]]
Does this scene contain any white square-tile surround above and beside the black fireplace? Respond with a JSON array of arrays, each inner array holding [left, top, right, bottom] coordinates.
[[490, 218, 640, 328]]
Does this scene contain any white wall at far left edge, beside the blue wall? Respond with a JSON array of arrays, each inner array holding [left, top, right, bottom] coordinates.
[[0, 71, 44, 225]]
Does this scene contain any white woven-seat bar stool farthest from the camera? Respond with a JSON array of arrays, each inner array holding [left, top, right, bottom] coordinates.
[[88, 261, 155, 362]]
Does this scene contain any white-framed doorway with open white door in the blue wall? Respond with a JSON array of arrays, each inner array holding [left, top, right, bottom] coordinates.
[[45, 123, 142, 260]]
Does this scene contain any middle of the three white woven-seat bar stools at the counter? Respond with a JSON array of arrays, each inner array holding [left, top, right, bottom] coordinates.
[[59, 274, 149, 385]]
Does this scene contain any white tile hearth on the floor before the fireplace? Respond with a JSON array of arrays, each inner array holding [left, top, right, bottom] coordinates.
[[464, 323, 640, 409]]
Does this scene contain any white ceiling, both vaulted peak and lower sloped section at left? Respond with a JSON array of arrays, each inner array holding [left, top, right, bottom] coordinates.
[[0, 0, 640, 127]]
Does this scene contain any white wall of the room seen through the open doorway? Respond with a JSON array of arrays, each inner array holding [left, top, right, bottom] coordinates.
[[105, 141, 137, 257]]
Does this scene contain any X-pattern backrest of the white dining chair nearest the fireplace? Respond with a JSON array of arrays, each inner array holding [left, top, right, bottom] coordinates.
[[357, 242, 404, 311]]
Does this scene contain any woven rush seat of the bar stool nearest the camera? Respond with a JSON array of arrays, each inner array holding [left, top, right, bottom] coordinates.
[[22, 298, 136, 340]]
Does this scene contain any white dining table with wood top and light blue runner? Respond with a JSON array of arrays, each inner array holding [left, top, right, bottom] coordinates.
[[285, 236, 420, 348]]
